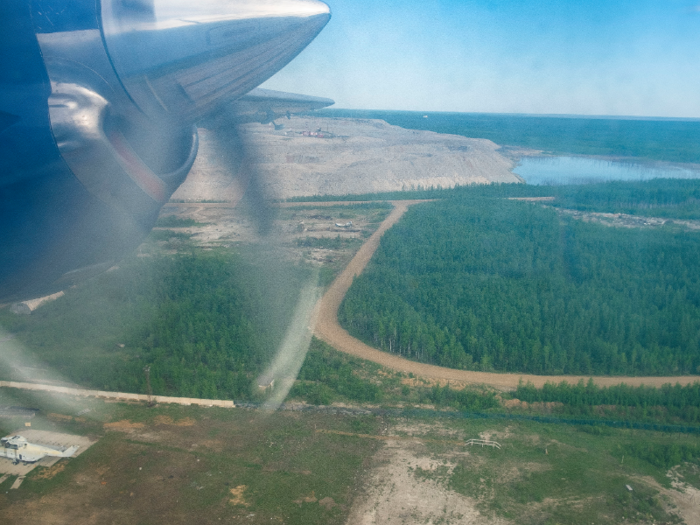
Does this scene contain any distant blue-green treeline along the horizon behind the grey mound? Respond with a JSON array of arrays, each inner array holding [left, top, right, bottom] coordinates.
[[310, 109, 700, 163]]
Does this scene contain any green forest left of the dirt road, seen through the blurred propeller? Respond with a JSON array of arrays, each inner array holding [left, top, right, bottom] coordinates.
[[0, 251, 311, 399]]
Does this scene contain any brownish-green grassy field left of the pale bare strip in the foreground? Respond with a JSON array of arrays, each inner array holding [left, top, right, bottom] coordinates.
[[0, 390, 378, 525]]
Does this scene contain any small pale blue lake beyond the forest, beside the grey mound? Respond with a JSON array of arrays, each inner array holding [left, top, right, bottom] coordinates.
[[513, 157, 700, 185]]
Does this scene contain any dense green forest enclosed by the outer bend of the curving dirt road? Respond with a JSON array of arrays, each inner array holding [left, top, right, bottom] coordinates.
[[339, 190, 700, 375]]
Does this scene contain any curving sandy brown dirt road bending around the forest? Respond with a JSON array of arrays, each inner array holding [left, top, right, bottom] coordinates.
[[315, 200, 700, 390]]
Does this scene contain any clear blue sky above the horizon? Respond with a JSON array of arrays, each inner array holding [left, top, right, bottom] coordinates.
[[263, 0, 700, 118]]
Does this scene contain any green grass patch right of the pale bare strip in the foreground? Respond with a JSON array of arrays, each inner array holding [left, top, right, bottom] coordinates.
[[438, 422, 698, 525]]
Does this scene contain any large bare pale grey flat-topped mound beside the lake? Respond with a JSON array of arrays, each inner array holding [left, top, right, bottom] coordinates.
[[173, 116, 522, 201]]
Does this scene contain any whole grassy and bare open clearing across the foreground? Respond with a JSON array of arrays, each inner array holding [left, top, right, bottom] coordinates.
[[0, 389, 700, 525]]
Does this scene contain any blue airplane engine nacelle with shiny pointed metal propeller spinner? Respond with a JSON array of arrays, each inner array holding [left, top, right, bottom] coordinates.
[[0, 0, 330, 301]]
